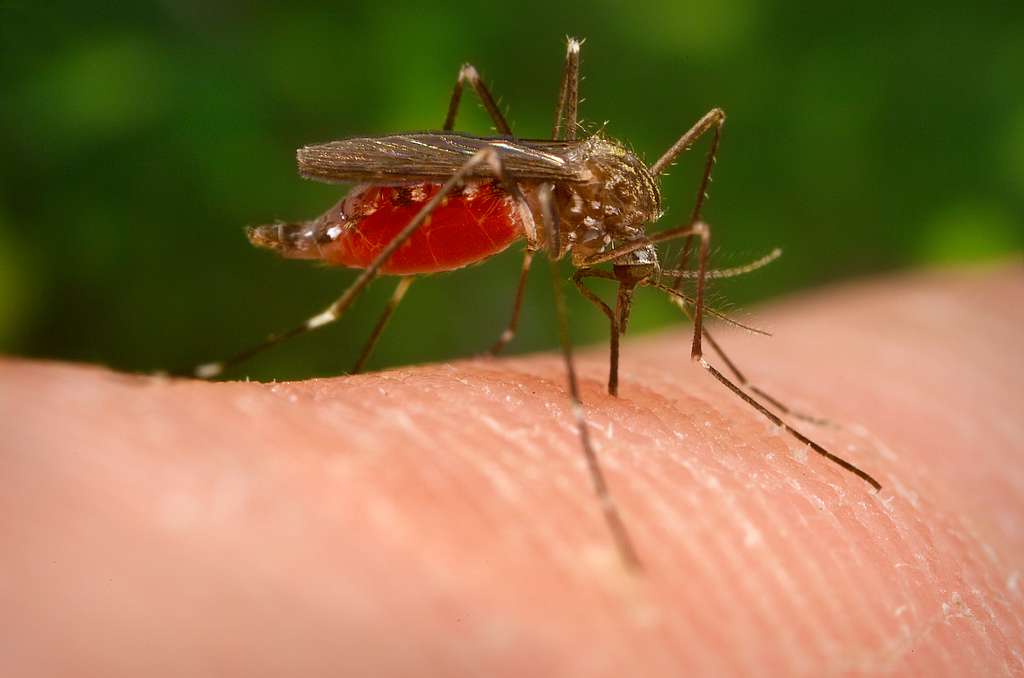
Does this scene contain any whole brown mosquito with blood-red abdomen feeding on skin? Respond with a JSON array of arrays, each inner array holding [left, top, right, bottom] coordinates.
[[194, 38, 881, 568]]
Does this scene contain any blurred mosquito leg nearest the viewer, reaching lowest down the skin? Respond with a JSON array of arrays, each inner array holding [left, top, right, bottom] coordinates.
[[538, 184, 641, 570]]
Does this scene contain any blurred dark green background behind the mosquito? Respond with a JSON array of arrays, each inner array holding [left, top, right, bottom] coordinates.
[[0, 0, 1024, 379]]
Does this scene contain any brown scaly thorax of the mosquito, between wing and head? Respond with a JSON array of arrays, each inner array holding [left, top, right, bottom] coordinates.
[[555, 135, 662, 263]]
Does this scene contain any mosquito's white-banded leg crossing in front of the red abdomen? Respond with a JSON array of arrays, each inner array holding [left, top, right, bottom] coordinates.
[[193, 146, 512, 379]]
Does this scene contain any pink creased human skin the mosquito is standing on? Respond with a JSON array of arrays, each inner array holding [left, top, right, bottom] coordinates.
[[0, 263, 1024, 676]]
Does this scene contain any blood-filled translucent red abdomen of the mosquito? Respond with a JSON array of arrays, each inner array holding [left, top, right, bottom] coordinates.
[[315, 181, 529, 276]]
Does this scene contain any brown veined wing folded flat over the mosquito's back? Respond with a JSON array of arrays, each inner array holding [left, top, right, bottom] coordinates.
[[296, 132, 588, 183]]
